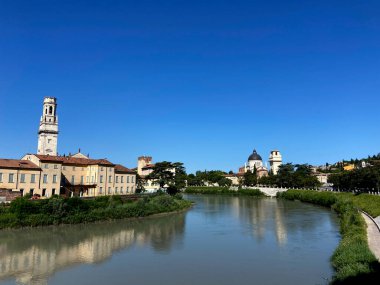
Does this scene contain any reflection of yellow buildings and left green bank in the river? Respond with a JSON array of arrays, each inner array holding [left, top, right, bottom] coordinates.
[[0, 213, 185, 284]]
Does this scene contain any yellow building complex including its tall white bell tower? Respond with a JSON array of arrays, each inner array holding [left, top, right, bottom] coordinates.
[[0, 97, 136, 197]]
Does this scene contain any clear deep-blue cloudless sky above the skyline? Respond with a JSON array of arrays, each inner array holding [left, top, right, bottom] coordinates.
[[0, 0, 380, 172]]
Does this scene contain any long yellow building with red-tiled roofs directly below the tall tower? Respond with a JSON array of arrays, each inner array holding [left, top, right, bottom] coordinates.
[[23, 153, 136, 197]]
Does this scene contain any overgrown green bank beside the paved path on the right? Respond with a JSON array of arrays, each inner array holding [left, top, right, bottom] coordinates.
[[278, 190, 380, 284]]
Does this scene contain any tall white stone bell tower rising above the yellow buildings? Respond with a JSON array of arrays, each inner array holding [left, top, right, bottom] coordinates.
[[37, 97, 58, 156]]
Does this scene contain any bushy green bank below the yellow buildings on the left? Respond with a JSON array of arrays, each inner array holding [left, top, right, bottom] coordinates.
[[0, 195, 191, 229]]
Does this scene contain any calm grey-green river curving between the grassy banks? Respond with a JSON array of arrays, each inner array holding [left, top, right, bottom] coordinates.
[[0, 195, 340, 285]]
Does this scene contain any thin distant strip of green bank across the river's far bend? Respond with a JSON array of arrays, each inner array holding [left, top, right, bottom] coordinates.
[[185, 187, 265, 197]]
